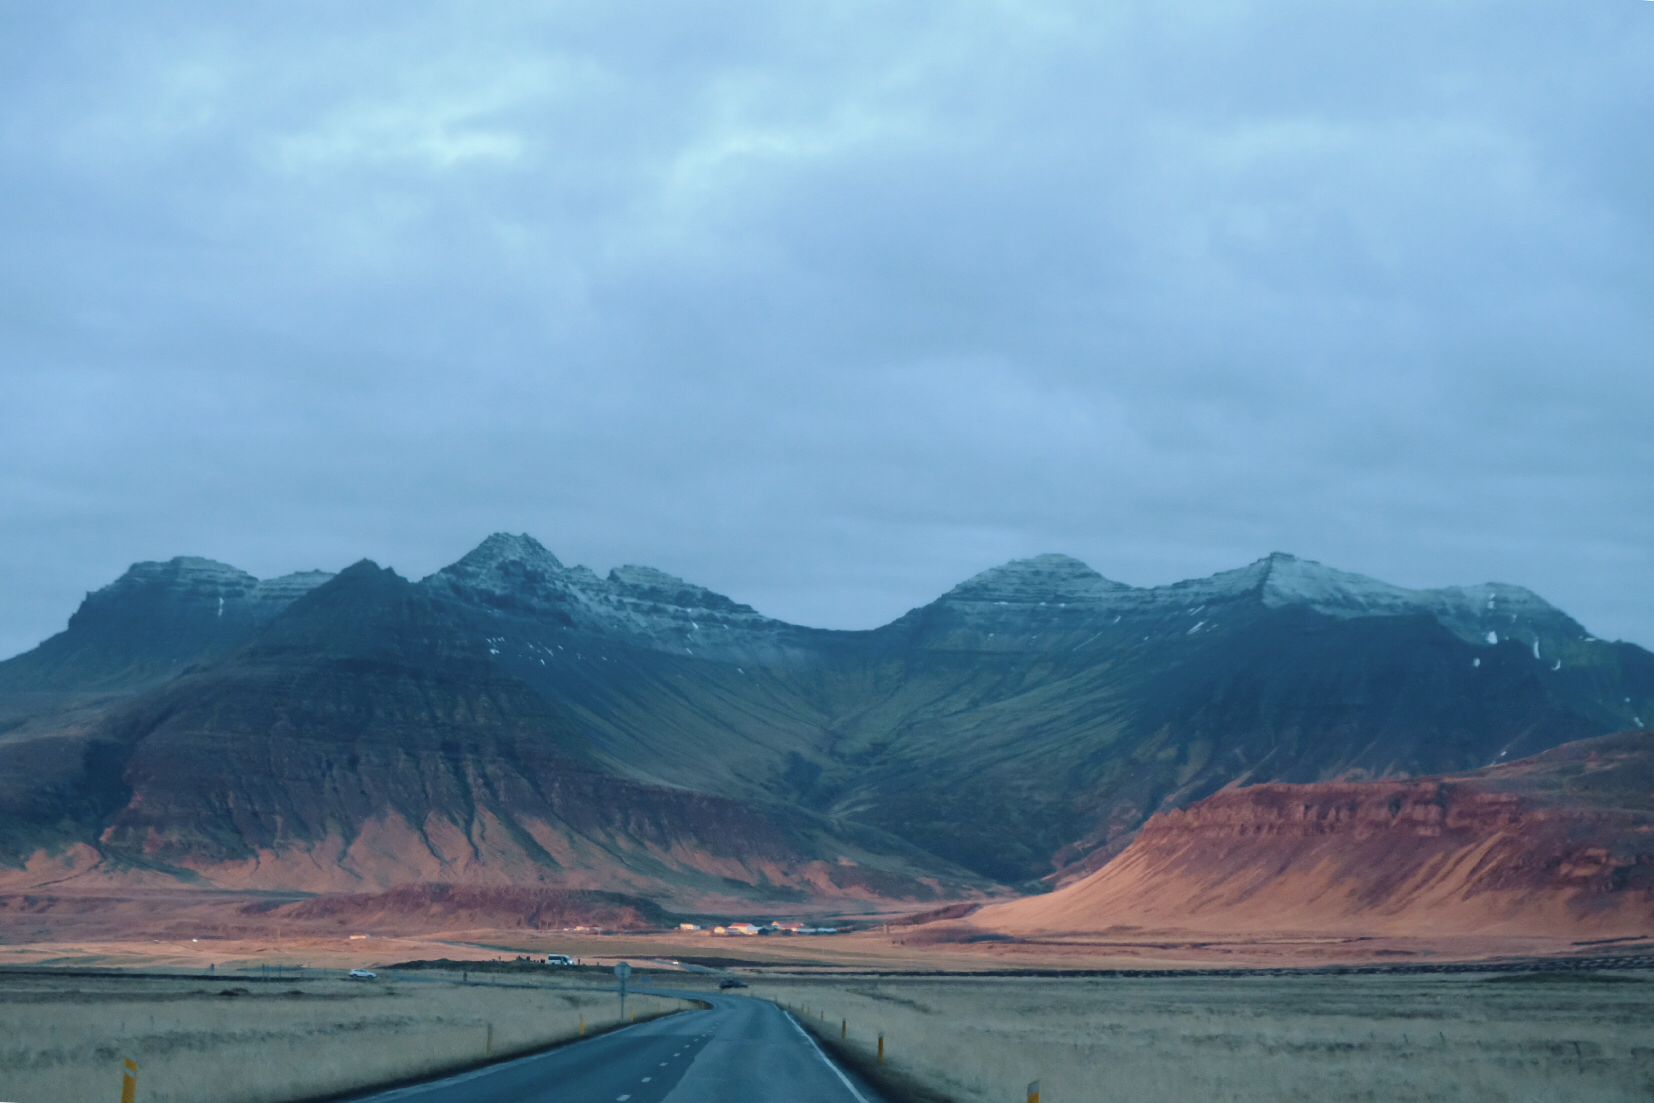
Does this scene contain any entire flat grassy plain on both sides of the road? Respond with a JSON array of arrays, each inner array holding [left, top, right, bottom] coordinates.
[[0, 931, 1654, 1103]]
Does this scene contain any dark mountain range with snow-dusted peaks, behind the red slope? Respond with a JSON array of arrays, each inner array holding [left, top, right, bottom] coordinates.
[[0, 534, 1654, 910]]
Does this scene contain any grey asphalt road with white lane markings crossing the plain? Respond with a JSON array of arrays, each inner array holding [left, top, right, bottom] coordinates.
[[362, 989, 882, 1103]]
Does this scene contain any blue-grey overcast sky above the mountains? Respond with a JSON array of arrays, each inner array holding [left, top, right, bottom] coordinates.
[[0, 0, 1654, 655]]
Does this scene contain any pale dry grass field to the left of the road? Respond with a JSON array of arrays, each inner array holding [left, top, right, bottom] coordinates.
[[0, 971, 688, 1103]]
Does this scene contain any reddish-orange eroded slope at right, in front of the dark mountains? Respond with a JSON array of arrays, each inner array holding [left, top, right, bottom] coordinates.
[[971, 731, 1654, 936]]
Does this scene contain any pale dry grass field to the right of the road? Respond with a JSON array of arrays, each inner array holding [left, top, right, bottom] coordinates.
[[753, 972, 1654, 1103]]
